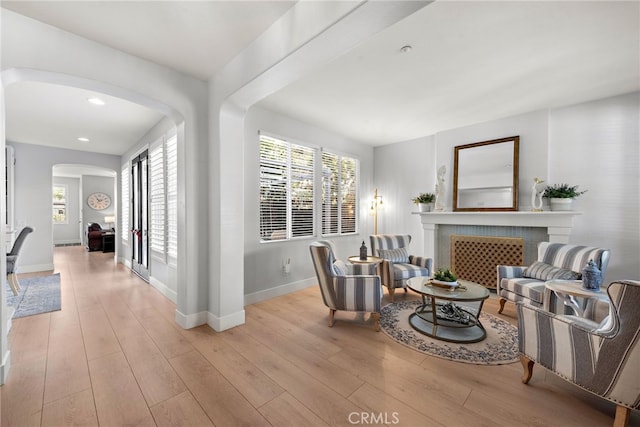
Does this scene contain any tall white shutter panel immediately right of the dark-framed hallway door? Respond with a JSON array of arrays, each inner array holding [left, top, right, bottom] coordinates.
[[149, 140, 166, 255]]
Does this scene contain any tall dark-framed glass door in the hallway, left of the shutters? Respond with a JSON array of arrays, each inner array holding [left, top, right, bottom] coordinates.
[[131, 150, 149, 281]]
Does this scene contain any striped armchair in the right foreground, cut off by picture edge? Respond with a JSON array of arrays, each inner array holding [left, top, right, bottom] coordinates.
[[516, 281, 640, 427]]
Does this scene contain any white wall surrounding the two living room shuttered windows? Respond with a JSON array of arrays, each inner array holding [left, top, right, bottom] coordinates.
[[244, 107, 374, 304]]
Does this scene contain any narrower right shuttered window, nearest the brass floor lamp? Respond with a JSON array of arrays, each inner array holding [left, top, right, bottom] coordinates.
[[321, 151, 359, 236]]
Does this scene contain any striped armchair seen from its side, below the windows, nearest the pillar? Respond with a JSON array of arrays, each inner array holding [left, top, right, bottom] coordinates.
[[309, 241, 382, 331]]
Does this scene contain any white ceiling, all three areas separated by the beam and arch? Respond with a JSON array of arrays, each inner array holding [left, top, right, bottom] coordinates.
[[2, 1, 640, 154]]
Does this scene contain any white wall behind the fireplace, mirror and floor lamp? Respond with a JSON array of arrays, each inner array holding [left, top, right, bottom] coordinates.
[[374, 93, 640, 282]]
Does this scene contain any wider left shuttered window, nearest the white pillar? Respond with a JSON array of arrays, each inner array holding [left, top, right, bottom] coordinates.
[[260, 135, 315, 241]]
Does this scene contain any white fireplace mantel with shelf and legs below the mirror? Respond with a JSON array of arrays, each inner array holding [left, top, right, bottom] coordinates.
[[413, 211, 582, 258]]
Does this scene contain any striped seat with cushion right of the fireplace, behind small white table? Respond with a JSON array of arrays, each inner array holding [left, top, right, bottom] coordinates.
[[497, 242, 610, 313]]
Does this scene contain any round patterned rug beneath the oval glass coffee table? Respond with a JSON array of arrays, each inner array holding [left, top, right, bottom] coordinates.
[[380, 301, 520, 365]]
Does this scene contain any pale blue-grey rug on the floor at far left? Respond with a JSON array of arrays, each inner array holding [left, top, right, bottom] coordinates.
[[5, 273, 61, 319]]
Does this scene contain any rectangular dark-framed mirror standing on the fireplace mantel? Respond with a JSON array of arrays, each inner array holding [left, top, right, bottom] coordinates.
[[453, 136, 520, 211]]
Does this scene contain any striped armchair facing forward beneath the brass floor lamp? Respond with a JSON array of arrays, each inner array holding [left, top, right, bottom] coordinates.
[[369, 234, 433, 301]]
